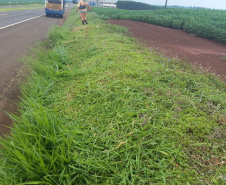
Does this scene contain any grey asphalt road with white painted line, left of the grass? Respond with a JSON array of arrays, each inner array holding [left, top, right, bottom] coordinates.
[[0, 9, 60, 94]]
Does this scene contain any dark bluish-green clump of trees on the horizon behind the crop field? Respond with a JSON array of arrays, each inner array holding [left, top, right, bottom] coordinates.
[[116, 1, 160, 10]]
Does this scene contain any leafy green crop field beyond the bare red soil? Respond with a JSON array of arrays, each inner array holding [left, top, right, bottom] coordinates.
[[93, 7, 226, 43]]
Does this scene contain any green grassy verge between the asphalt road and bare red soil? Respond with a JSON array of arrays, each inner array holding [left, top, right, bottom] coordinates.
[[0, 8, 226, 185]]
